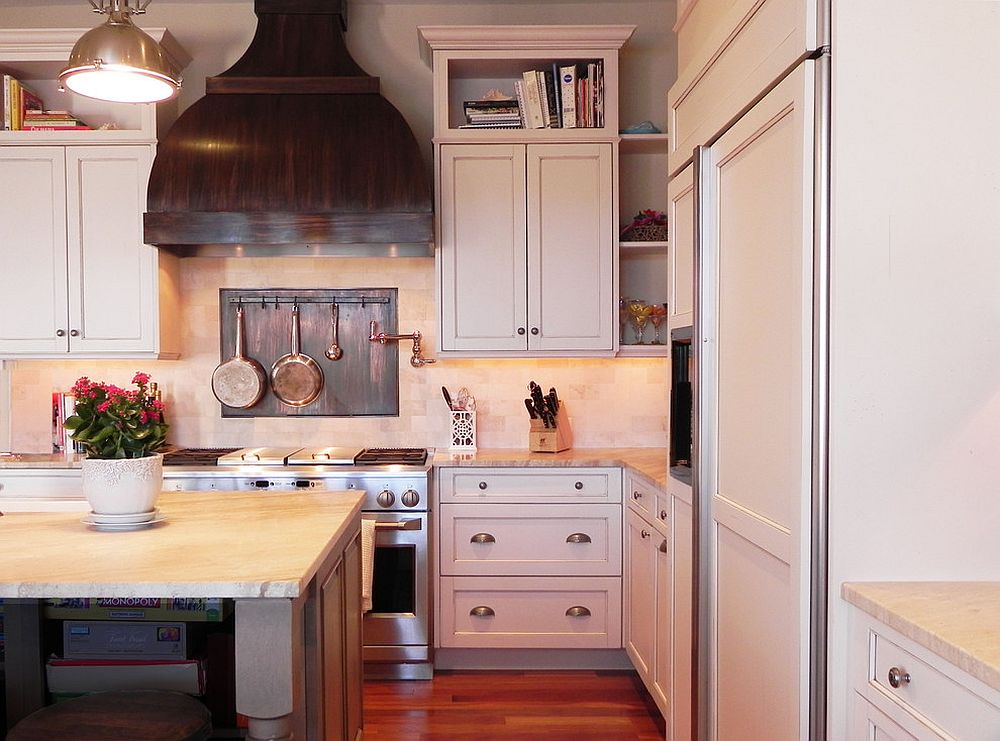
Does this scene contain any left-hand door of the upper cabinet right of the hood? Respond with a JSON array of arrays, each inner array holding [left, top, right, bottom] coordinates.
[[438, 144, 528, 350]]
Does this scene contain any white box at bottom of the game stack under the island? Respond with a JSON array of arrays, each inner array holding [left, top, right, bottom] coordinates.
[[45, 659, 205, 695]]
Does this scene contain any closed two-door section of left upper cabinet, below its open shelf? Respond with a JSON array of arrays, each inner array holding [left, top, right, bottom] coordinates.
[[0, 144, 177, 358]]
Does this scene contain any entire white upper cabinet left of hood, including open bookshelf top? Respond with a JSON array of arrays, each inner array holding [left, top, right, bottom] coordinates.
[[0, 29, 188, 358]]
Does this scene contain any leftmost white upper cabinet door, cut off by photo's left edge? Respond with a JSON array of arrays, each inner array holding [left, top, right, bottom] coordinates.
[[0, 147, 68, 353]]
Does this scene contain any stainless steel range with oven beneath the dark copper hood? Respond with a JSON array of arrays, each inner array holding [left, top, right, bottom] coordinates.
[[163, 447, 434, 679]]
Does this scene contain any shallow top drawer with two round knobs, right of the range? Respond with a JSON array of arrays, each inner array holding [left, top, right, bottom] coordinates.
[[438, 468, 622, 504]]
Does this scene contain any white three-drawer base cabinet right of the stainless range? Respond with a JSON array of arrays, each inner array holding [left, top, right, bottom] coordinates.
[[435, 467, 622, 649]]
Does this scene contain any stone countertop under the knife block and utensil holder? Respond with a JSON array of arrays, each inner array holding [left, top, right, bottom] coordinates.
[[434, 448, 669, 490]]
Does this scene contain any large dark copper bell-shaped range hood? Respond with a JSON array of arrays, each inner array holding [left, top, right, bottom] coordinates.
[[144, 0, 433, 256]]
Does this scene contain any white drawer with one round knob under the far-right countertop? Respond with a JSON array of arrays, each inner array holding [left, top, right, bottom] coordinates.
[[868, 629, 1000, 741]]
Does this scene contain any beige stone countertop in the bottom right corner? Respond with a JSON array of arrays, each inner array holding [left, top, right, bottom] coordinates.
[[841, 582, 1000, 691]]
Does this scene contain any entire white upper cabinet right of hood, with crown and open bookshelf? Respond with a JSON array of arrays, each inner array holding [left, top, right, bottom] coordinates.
[[420, 26, 635, 356]]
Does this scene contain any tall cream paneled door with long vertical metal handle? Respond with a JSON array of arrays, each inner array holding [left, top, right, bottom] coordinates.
[[699, 62, 814, 741]]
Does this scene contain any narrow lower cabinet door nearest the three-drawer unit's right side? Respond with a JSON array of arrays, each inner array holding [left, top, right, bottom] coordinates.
[[625, 510, 661, 685]]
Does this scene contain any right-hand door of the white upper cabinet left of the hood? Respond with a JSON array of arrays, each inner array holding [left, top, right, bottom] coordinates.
[[66, 145, 159, 352]]
